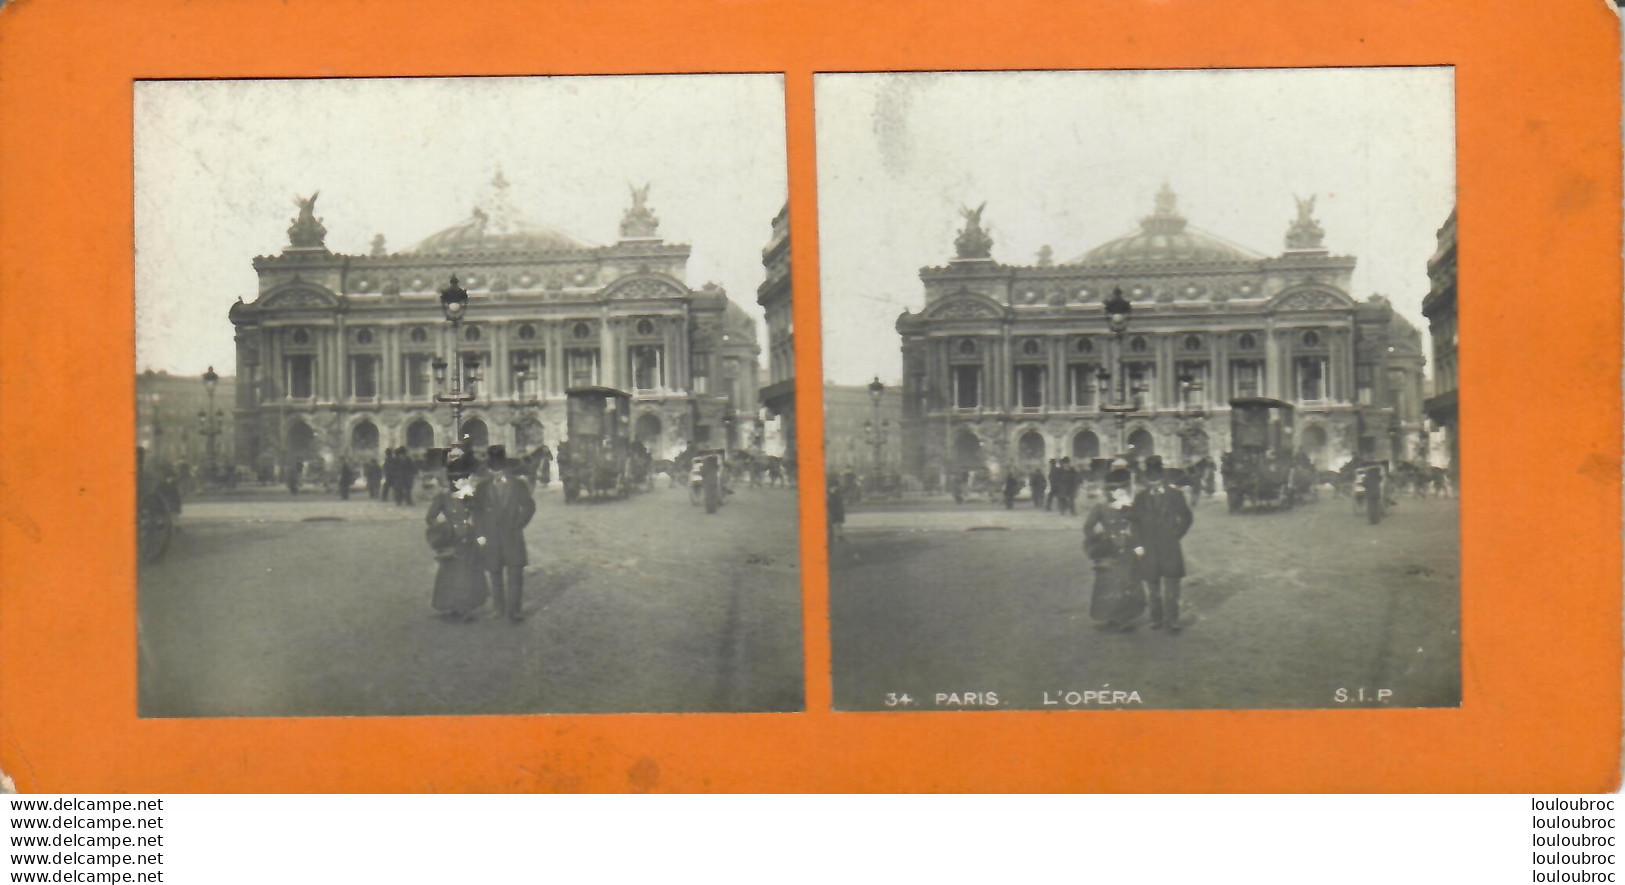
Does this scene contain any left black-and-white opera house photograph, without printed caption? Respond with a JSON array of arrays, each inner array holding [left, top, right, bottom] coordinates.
[[132, 75, 804, 718]]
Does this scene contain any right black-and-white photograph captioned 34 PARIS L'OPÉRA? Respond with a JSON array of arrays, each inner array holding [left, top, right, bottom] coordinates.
[[814, 68, 1461, 711]]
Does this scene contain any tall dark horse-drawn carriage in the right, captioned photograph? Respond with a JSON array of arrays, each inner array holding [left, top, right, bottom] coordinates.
[[1222, 396, 1313, 513]]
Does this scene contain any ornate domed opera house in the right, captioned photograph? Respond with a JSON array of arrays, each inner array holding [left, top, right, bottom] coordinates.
[[897, 185, 1424, 476]]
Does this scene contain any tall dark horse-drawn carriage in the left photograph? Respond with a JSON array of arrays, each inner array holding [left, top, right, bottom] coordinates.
[[557, 386, 634, 503]]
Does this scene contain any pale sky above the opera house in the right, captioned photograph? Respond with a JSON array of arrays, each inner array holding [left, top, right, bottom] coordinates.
[[814, 68, 1456, 383]]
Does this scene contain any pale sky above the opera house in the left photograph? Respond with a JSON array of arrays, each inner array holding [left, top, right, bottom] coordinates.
[[135, 75, 787, 375]]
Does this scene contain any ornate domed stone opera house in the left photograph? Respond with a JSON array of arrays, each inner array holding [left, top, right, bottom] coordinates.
[[231, 174, 759, 474]]
